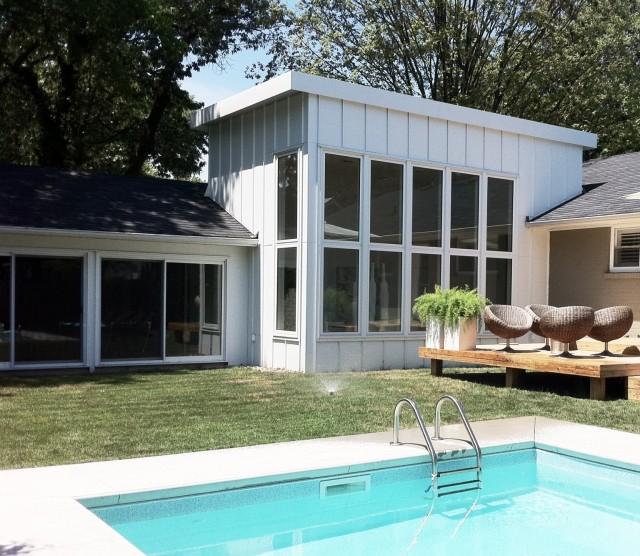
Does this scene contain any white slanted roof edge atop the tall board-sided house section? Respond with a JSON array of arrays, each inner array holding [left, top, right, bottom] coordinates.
[[191, 71, 598, 148]]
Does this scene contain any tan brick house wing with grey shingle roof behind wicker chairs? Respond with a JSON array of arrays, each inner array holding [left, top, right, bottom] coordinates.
[[529, 152, 640, 338]]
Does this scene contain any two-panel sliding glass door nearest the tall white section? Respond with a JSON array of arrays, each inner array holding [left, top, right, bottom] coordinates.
[[101, 259, 223, 361]]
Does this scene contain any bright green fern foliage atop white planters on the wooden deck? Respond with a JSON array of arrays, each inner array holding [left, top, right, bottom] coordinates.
[[413, 286, 489, 326]]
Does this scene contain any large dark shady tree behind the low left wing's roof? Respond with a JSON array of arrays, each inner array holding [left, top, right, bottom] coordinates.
[[0, 0, 278, 176]]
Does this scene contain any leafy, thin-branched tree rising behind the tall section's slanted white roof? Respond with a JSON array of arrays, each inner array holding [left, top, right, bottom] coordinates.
[[255, 0, 640, 154]]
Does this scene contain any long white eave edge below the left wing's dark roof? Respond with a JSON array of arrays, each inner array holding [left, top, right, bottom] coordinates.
[[0, 226, 258, 247]]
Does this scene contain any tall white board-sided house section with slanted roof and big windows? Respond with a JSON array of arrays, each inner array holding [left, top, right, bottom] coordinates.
[[193, 72, 597, 371]]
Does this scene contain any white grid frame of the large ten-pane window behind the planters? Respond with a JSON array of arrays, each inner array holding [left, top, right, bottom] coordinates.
[[316, 146, 520, 341]]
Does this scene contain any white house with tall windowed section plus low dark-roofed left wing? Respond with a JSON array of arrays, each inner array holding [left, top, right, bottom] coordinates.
[[0, 72, 620, 371]]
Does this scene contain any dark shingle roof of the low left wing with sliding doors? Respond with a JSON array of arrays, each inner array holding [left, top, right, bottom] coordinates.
[[0, 165, 253, 239]]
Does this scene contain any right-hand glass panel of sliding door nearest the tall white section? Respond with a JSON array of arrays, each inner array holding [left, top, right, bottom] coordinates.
[[165, 263, 222, 357]]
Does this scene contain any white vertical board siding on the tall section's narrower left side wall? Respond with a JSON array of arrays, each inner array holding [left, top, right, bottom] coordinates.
[[210, 94, 307, 370]]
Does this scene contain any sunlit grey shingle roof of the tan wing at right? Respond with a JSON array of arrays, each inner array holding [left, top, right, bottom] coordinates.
[[531, 152, 640, 223]]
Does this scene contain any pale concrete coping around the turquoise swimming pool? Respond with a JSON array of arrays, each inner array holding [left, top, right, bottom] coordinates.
[[0, 417, 640, 555]]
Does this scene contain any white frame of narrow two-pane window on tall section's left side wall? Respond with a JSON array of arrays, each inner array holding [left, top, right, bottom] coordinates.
[[272, 146, 302, 340]]
